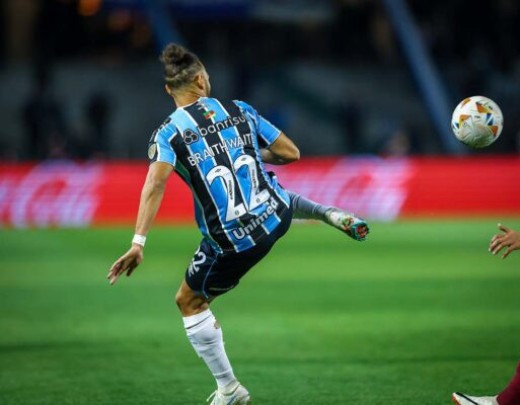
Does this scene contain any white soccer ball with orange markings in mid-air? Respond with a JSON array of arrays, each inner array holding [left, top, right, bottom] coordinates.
[[451, 96, 504, 148]]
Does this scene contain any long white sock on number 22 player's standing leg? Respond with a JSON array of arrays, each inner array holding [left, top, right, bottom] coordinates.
[[182, 309, 238, 393]]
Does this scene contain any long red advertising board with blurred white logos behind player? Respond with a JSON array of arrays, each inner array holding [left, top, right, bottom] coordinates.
[[0, 156, 520, 228]]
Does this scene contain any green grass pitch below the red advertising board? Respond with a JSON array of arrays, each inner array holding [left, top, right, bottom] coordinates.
[[0, 219, 520, 405]]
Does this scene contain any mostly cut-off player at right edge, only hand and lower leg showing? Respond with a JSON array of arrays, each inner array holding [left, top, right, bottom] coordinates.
[[452, 224, 520, 405]]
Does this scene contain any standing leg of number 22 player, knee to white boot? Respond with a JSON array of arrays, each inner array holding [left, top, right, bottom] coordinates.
[[176, 281, 250, 405]]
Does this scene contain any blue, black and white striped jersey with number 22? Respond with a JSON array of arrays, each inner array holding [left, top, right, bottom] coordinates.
[[148, 97, 290, 252]]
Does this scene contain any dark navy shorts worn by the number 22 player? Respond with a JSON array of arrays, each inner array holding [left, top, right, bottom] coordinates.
[[185, 209, 292, 299]]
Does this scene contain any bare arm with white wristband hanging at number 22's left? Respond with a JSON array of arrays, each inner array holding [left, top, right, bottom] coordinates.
[[107, 162, 173, 284]]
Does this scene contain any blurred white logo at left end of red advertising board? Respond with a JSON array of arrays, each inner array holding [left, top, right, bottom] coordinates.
[[0, 162, 102, 228]]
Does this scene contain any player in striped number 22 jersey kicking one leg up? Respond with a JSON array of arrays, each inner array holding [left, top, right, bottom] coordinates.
[[108, 44, 369, 405]]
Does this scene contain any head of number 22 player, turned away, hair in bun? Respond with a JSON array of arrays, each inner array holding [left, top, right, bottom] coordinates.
[[160, 44, 211, 96]]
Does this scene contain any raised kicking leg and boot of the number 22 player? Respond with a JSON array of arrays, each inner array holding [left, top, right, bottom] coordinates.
[[287, 190, 370, 241]]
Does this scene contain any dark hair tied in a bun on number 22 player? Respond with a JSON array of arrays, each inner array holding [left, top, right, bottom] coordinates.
[[159, 44, 203, 90]]
